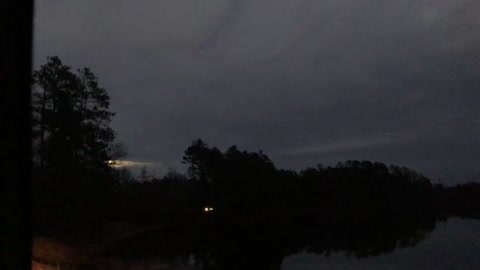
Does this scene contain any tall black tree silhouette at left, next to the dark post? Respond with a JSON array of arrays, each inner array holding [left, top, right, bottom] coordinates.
[[32, 57, 115, 184]]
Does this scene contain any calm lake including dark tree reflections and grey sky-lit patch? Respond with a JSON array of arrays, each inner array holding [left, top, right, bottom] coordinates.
[[82, 218, 480, 270]]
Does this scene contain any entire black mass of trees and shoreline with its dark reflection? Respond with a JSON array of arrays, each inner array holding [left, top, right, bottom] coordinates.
[[32, 57, 480, 269]]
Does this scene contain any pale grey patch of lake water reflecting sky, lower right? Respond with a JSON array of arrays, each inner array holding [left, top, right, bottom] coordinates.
[[282, 218, 480, 270]]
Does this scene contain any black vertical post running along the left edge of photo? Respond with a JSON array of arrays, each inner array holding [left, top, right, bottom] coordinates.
[[0, 0, 33, 270]]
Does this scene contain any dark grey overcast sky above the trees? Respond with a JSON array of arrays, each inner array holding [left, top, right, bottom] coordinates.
[[34, 0, 480, 183]]
